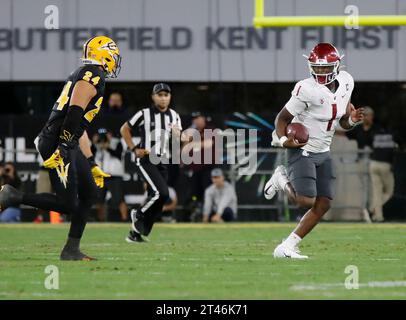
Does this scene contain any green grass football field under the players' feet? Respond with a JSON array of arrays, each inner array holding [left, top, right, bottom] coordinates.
[[0, 223, 406, 299]]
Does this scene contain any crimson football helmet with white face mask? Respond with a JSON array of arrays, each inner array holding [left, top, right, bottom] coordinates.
[[303, 42, 344, 85]]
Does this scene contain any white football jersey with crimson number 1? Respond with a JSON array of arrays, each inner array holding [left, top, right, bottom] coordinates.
[[285, 71, 354, 153]]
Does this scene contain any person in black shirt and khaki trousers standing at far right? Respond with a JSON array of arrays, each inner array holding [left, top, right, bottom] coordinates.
[[349, 107, 397, 222]]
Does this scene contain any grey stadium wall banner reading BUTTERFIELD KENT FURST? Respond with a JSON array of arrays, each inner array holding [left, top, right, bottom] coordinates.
[[0, 0, 406, 82]]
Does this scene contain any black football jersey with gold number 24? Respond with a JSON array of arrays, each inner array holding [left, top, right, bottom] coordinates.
[[40, 65, 105, 141]]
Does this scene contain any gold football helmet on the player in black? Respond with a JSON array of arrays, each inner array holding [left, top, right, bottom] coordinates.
[[82, 36, 121, 78]]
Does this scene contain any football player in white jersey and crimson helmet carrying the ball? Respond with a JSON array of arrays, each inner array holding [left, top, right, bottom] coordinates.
[[264, 43, 363, 259]]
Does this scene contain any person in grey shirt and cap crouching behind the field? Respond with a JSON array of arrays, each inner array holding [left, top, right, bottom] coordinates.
[[203, 168, 237, 222]]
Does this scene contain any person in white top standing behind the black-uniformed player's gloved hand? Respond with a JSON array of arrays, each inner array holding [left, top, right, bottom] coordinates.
[[92, 128, 128, 221]]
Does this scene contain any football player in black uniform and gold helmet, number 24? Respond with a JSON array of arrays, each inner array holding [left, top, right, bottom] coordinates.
[[0, 36, 121, 260]]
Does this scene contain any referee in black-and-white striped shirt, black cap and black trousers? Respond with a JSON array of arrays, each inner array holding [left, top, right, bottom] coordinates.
[[120, 83, 186, 242]]
